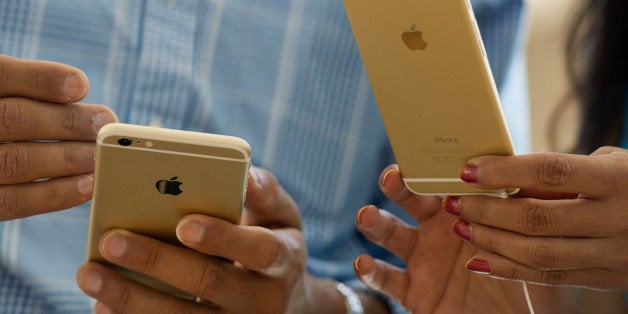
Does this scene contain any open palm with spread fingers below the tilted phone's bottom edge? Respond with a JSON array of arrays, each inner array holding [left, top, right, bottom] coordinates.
[[355, 166, 576, 313]]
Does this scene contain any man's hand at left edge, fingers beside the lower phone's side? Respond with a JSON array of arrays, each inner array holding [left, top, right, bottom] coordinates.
[[0, 55, 116, 221]]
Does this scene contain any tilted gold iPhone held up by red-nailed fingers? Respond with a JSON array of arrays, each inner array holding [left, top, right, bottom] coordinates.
[[344, 0, 515, 195]]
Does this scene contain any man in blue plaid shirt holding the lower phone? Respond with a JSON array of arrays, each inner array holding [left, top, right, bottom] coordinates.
[[0, 0, 528, 313]]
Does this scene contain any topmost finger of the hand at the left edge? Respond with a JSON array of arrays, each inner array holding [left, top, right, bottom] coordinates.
[[0, 55, 89, 103]]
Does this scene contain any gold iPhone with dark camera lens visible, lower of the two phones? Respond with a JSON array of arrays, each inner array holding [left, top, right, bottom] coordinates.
[[87, 123, 251, 297]]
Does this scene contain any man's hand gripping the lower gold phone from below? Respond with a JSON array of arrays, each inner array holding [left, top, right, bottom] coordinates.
[[77, 168, 324, 313]]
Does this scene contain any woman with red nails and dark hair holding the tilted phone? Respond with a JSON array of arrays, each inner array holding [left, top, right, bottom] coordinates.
[[355, 0, 628, 313]]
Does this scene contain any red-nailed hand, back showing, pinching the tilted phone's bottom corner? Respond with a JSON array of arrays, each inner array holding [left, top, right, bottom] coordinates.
[[444, 147, 628, 289]]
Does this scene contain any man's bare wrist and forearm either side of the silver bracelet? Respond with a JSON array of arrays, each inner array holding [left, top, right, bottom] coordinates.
[[302, 274, 390, 314]]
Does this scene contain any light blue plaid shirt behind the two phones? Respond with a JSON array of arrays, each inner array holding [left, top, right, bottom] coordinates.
[[0, 0, 529, 313]]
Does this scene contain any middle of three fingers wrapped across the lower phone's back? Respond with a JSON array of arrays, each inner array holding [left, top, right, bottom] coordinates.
[[99, 230, 262, 308]]
